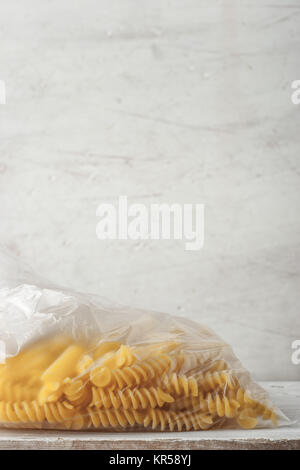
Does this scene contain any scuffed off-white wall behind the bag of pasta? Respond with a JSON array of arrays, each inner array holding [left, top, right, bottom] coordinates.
[[0, 0, 300, 380]]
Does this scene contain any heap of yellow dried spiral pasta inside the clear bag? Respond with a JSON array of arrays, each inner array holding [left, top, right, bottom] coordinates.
[[0, 338, 277, 431]]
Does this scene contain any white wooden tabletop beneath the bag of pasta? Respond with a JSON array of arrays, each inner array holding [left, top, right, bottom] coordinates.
[[0, 382, 300, 450]]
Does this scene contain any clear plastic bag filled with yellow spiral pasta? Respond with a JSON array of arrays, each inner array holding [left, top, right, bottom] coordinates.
[[0, 255, 288, 431]]
